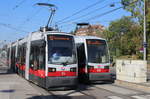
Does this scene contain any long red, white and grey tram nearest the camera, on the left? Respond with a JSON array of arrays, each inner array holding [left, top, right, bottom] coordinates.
[[8, 31, 78, 89]]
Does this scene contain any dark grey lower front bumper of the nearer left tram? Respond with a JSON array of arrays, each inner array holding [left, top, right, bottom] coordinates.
[[46, 77, 77, 89]]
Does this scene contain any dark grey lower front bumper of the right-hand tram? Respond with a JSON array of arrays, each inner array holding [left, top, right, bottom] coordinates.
[[89, 73, 112, 81]]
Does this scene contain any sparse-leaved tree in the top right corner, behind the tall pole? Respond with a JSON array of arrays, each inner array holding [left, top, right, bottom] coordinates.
[[121, 0, 150, 60]]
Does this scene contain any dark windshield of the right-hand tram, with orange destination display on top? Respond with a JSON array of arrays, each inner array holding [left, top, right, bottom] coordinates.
[[86, 39, 109, 63]]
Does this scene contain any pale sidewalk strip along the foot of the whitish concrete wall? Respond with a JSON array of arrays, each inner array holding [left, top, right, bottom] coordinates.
[[115, 80, 150, 93]]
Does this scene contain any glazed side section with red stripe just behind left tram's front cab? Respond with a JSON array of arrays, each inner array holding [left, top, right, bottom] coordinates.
[[29, 41, 45, 86]]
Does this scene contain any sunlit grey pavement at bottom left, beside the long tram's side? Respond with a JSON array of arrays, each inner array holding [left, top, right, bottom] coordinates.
[[0, 66, 46, 99]]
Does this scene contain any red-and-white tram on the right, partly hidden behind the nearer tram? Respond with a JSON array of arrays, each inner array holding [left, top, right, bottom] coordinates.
[[75, 36, 111, 83]]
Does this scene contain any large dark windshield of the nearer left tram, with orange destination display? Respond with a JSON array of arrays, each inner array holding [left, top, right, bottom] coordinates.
[[48, 35, 76, 65]]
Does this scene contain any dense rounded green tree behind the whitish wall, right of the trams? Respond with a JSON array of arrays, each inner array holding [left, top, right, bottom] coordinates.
[[104, 17, 142, 58]]
